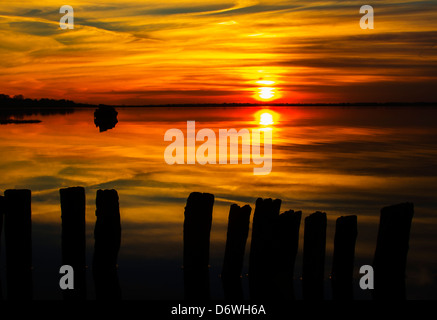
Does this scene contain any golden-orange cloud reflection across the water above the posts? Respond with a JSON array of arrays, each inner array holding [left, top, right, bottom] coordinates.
[[2, 108, 437, 216]]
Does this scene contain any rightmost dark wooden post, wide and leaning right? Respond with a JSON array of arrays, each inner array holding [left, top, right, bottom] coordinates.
[[372, 203, 414, 300]]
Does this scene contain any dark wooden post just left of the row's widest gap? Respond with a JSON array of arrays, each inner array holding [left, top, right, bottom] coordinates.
[[93, 190, 121, 300]]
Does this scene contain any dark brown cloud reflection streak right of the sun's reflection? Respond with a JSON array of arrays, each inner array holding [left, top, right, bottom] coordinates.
[[275, 138, 437, 177]]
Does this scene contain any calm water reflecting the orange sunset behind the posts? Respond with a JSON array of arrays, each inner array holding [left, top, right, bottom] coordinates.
[[0, 107, 437, 299]]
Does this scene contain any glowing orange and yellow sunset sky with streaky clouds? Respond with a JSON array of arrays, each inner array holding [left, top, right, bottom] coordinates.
[[0, 0, 437, 104]]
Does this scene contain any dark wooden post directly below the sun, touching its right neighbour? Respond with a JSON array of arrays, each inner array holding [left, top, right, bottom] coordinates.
[[249, 198, 281, 299]]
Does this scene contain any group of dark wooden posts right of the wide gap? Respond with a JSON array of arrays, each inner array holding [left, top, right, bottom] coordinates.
[[184, 192, 414, 301]]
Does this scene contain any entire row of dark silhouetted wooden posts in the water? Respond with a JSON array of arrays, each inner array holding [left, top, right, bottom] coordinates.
[[0, 187, 414, 300]]
